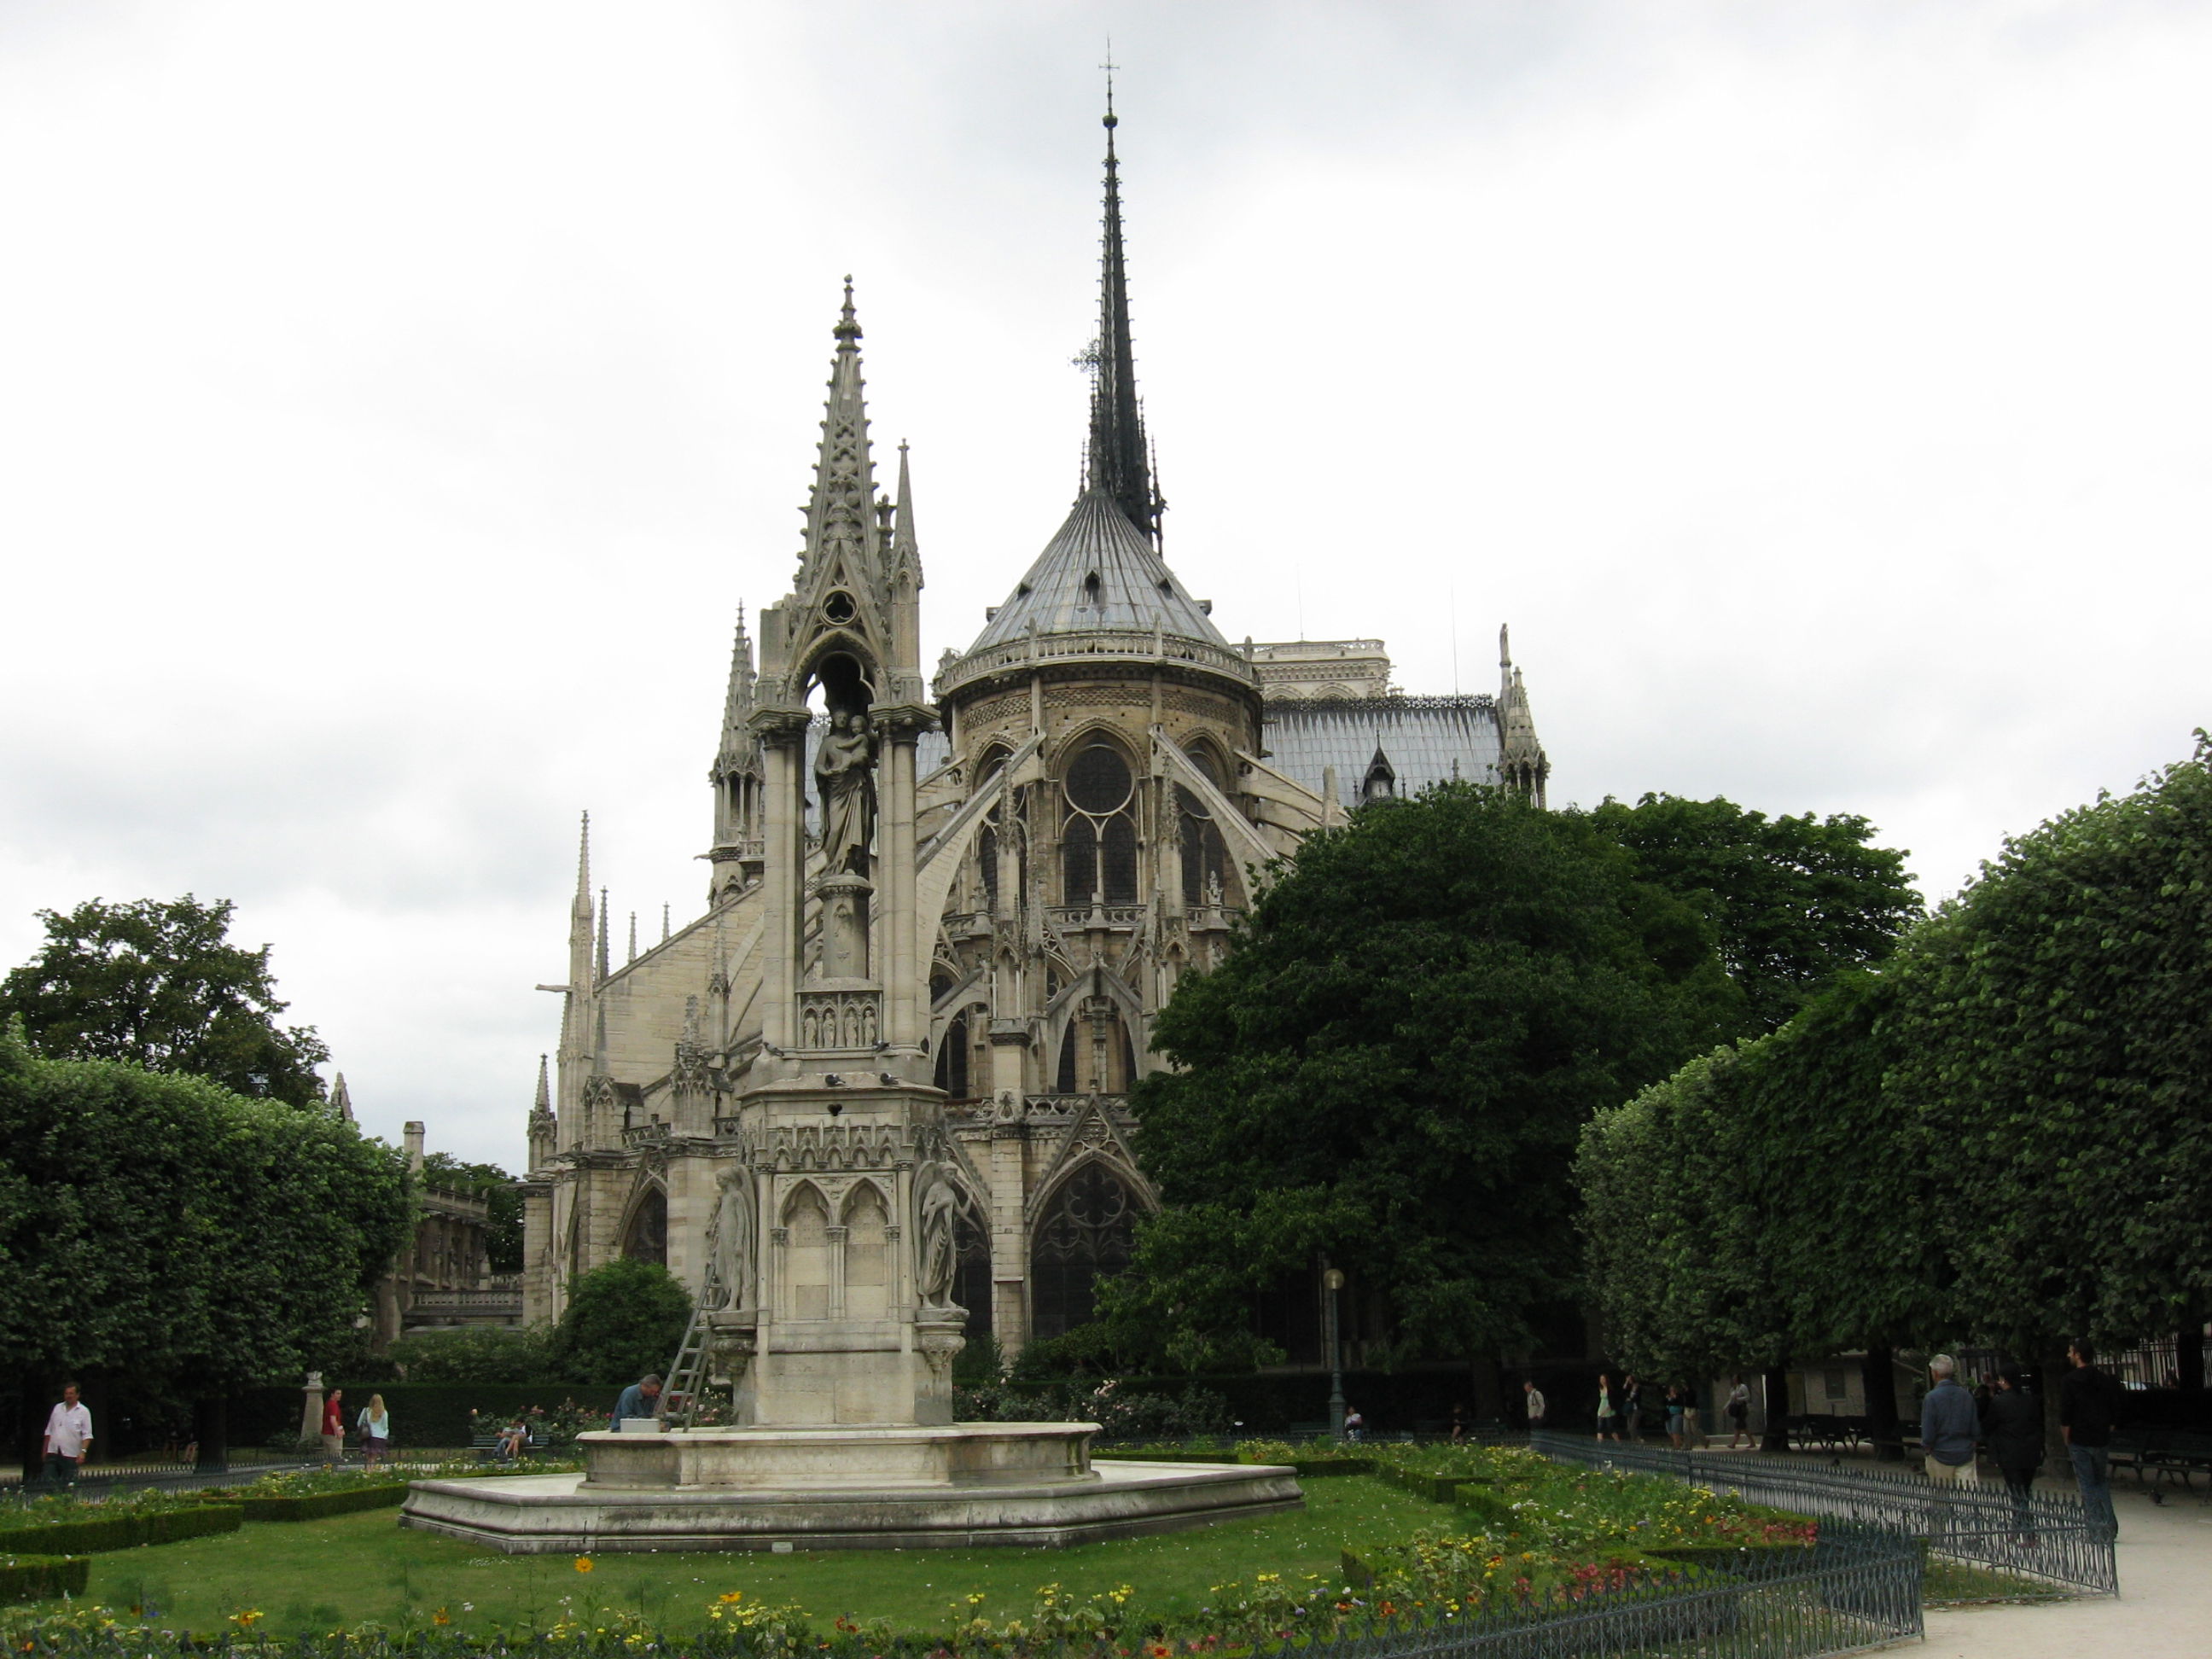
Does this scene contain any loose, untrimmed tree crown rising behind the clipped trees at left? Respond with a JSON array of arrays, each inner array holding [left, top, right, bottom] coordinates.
[[0, 894, 329, 1106]]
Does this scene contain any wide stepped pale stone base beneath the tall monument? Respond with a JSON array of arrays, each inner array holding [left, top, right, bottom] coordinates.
[[400, 1423, 1305, 1555]]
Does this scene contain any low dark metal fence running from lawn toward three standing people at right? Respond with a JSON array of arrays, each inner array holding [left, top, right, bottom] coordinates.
[[1531, 1434, 2119, 1595]]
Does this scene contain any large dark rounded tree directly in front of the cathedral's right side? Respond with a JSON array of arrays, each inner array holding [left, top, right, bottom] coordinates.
[[1109, 785, 1743, 1365]]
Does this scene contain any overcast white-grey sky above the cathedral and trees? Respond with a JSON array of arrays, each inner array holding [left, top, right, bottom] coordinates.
[[0, 0, 2212, 1168]]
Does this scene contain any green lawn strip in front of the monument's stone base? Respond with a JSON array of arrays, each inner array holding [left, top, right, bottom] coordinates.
[[89, 1476, 1451, 1634]]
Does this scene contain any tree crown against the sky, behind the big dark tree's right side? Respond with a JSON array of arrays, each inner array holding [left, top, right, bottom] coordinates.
[[1591, 795, 1920, 1033]]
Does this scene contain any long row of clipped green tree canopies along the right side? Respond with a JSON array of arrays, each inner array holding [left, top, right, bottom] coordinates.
[[1577, 736, 2212, 1365]]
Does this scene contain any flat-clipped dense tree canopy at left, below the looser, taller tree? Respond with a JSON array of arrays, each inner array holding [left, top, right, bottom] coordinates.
[[0, 1020, 414, 1394]]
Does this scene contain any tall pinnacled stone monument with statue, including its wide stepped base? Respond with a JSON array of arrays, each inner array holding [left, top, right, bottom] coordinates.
[[403, 285, 1303, 1553]]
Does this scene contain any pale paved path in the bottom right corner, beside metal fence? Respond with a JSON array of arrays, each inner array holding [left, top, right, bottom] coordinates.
[[1920, 1482, 2212, 1659]]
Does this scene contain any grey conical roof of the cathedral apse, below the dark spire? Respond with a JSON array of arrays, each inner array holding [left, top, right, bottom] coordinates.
[[969, 485, 1228, 655]]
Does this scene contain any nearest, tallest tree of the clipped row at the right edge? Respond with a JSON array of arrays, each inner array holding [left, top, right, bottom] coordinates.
[[1891, 732, 2212, 1356]]
